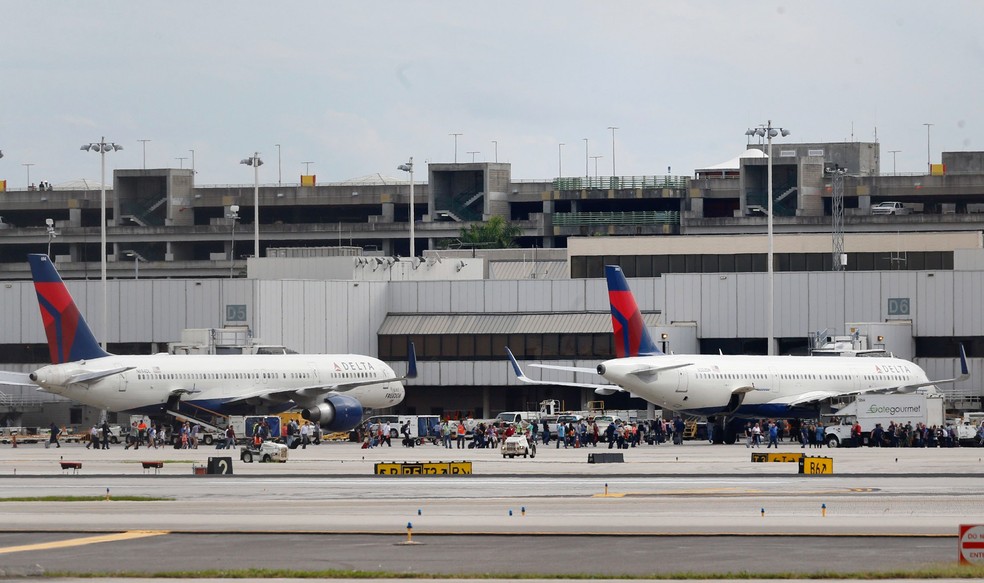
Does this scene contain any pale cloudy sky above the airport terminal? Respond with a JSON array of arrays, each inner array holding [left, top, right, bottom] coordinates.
[[0, 0, 984, 189]]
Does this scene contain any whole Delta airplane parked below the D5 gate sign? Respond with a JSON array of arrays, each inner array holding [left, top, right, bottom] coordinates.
[[0, 254, 417, 431]]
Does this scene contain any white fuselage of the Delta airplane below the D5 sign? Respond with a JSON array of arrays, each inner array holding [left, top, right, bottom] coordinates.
[[32, 354, 404, 413]]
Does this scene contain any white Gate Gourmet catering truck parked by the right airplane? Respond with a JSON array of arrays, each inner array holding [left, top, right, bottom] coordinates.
[[824, 393, 945, 447]]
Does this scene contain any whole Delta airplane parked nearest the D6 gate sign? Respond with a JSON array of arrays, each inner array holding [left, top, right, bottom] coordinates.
[[507, 265, 969, 441]]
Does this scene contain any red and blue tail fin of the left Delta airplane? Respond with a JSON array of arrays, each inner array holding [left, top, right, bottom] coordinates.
[[27, 254, 109, 364]]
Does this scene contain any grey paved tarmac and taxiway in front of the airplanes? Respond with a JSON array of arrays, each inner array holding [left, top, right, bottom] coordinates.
[[0, 442, 984, 579]]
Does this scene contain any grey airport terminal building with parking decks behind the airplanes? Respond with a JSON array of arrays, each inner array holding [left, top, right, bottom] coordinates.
[[0, 143, 984, 424]]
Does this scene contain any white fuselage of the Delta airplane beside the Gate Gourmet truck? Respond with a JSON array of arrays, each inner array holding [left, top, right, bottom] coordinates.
[[599, 355, 929, 418]]
